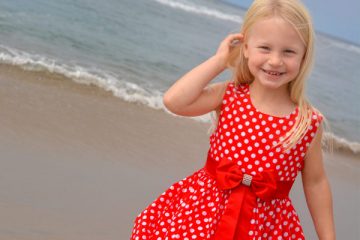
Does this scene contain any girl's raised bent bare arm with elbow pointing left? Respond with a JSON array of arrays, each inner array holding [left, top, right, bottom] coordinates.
[[163, 34, 242, 116]]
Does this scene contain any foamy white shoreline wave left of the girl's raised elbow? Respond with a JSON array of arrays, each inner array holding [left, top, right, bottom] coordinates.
[[0, 45, 164, 109]]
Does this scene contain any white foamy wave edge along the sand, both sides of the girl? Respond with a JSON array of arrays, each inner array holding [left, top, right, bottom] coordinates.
[[0, 45, 360, 155]]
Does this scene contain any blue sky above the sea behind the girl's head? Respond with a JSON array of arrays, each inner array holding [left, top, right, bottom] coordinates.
[[226, 0, 360, 45]]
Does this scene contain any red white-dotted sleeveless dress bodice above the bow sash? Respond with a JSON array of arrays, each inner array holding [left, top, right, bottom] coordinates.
[[209, 82, 322, 181]]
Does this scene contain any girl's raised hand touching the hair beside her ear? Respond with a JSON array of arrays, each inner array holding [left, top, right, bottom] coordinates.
[[215, 33, 244, 66]]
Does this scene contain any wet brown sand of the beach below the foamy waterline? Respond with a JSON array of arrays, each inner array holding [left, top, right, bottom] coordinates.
[[0, 65, 360, 240]]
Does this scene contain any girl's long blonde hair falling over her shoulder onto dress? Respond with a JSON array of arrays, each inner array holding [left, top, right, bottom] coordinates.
[[211, 0, 328, 151]]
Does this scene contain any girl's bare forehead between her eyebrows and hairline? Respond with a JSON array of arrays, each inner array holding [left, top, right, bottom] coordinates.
[[248, 16, 305, 47]]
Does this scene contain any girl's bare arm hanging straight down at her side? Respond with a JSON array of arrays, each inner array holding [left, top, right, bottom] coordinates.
[[302, 125, 335, 240]]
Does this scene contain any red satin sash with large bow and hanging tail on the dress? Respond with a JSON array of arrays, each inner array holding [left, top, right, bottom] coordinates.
[[204, 150, 294, 240]]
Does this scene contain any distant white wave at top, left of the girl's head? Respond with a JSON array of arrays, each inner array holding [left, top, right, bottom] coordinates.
[[154, 0, 243, 23]]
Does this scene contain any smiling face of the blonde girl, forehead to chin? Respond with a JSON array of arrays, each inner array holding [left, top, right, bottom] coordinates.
[[244, 16, 305, 88]]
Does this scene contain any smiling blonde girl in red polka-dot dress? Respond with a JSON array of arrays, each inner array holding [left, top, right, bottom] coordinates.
[[131, 0, 335, 240]]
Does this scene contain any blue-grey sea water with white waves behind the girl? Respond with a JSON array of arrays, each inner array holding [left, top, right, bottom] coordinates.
[[0, 0, 360, 154]]
